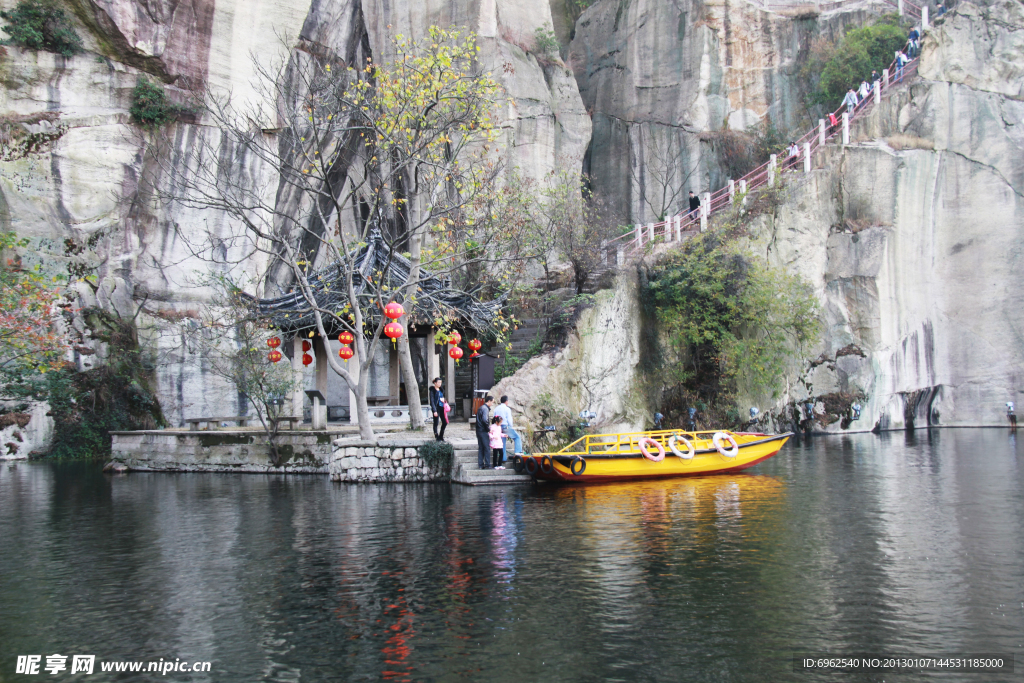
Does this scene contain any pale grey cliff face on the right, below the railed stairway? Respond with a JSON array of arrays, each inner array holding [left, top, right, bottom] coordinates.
[[763, 1, 1024, 429]]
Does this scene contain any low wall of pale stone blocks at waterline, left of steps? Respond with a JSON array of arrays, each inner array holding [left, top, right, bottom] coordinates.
[[330, 438, 452, 483]]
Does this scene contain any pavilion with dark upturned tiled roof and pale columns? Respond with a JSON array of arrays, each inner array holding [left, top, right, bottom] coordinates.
[[256, 230, 505, 429]]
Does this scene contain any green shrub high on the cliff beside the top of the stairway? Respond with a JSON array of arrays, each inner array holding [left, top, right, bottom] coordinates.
[[812, 15, 906, 109]]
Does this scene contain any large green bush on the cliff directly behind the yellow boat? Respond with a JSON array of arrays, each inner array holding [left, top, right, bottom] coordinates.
[[642, 226, 818, 426]]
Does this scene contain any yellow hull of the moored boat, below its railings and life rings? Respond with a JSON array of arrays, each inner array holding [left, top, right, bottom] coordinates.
[[523, 434, 793, 483]]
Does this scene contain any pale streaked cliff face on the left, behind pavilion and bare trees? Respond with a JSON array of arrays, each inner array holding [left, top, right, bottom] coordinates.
[[0, 0, 590, 432]]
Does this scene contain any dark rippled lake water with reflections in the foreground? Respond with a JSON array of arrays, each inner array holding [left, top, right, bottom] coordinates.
[[0, 429, 1024, 682]]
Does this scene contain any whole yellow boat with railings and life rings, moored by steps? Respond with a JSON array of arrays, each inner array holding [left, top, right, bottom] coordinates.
[[513, 429, 793, 482]]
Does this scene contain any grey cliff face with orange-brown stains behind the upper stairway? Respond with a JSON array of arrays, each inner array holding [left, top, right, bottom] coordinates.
[[568, 0, 881, 222]]
